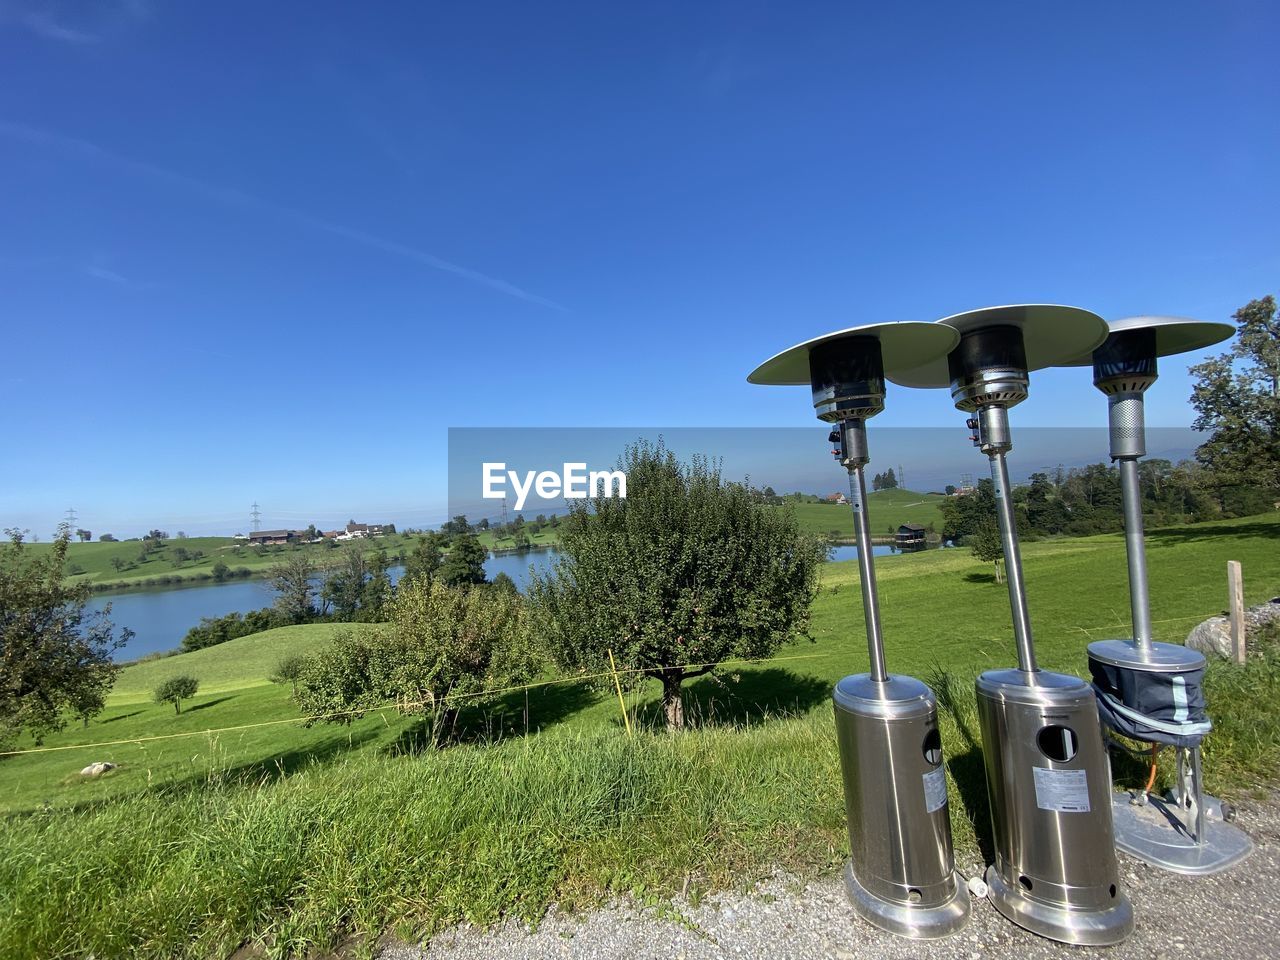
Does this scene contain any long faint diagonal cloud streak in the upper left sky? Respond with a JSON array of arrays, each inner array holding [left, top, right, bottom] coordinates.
[[0, 120, 567, 312]]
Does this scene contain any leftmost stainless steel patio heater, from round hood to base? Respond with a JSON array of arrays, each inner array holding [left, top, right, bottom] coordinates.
[[748, 323, 969, 940]]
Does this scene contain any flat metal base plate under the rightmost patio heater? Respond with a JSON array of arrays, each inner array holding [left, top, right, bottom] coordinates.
[[1111, 792, 1253, 877]]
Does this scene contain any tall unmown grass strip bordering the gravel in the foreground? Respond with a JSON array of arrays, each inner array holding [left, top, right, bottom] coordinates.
[[0, 646, 1280, 960]]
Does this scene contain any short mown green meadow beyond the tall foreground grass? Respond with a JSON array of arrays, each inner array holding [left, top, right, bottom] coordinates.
[[0, 507, 1280, 812]]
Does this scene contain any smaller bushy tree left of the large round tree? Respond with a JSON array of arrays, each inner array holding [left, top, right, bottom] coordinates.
[[296, 580, 536, 739]]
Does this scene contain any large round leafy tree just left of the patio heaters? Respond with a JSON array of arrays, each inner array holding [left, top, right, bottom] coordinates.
[[530, 443, 826, 730]]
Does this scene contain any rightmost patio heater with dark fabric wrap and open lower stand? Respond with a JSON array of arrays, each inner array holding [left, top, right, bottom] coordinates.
[[1076, 316, 1253, 874]]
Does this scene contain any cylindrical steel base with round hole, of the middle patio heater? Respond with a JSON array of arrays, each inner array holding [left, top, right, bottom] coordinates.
[[977, 669, 1133, 946]]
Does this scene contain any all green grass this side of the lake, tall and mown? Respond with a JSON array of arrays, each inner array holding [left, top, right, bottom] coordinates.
[[0, 513, 1280, 957]]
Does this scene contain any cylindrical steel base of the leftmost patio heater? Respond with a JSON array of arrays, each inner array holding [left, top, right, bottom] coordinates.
[[833, 673, 969, 940]]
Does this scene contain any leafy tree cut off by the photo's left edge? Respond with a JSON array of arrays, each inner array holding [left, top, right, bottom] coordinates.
[[0, 527, 133, 742]]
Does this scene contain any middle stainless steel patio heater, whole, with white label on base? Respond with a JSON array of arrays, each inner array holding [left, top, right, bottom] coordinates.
[[890, 305, 1133, 946]]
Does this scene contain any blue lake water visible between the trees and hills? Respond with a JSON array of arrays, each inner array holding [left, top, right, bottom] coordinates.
[[88, 544, 931, 660]]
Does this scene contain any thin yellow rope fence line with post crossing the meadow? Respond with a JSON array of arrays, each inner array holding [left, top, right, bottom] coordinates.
[[0, 614, 1233, 756]]
